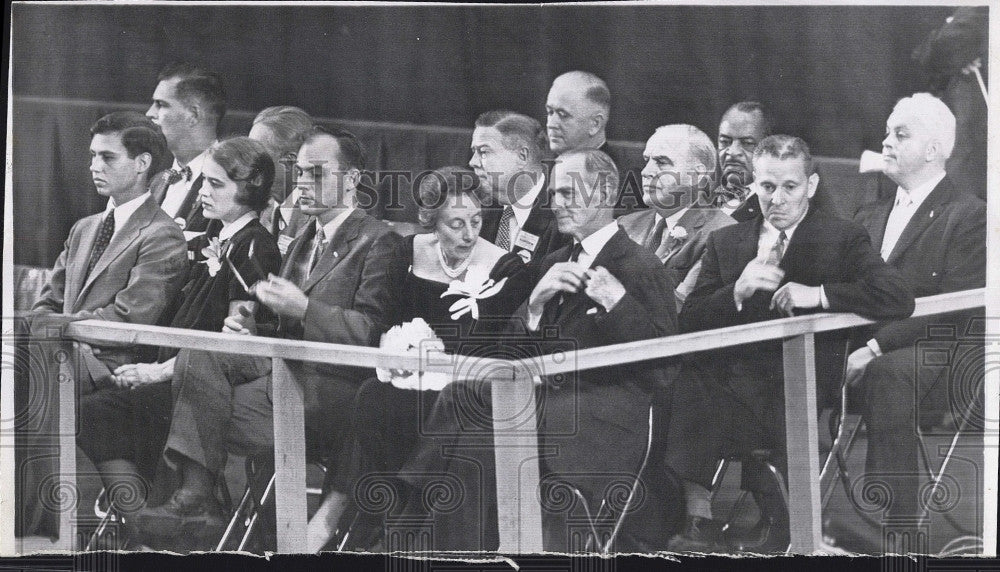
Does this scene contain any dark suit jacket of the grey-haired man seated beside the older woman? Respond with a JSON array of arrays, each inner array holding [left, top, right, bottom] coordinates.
[[522, 230, 677, 482]]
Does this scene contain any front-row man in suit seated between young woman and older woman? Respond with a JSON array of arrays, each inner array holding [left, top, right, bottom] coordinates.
[[132, 126, 395, 550]]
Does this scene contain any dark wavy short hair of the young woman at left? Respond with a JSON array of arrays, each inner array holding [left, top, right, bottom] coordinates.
[[208, 137, 274, 213]]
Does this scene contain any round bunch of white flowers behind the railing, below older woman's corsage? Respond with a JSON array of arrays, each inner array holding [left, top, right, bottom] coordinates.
[[375, 318, 451, 391]]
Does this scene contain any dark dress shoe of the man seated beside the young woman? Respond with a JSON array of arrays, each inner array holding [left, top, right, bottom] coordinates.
[[127, 489, 227, 552]]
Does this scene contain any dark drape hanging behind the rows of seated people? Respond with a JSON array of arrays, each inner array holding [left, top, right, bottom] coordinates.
[[11, 5, 952, 265]]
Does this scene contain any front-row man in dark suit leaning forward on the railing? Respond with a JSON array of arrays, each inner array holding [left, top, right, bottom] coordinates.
[[666, 135, 913, 552]]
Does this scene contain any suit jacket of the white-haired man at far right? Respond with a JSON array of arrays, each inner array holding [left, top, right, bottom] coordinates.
[[855, 176, 986, 352]]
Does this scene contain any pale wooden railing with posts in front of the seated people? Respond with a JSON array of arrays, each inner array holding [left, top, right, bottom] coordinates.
[[11, 289, 985, 554]]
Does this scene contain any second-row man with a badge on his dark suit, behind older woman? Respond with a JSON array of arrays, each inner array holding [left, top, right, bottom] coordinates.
[[469, 111, 568, 262]]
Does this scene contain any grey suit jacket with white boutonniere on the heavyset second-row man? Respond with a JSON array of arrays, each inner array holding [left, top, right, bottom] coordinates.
[[618, 206, 736, 309]]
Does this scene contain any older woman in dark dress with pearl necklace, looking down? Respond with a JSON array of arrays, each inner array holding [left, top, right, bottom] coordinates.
[[306, 167, 534, 552]]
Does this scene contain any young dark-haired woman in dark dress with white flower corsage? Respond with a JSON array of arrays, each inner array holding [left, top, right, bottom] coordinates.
[[77, 137, 281, 532]]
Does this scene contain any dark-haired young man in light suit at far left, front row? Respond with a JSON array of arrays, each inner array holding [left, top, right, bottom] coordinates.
[[16, 111, 188, 535]]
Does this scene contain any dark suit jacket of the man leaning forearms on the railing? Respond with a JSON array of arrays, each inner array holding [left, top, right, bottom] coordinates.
[[679, 208, 913, 388]]
